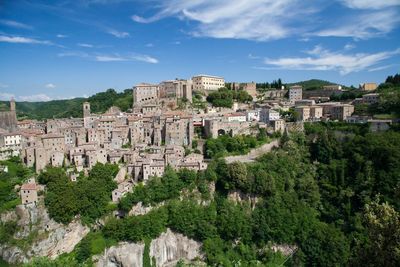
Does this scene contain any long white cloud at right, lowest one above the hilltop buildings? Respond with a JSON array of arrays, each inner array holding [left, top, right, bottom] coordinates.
[[264, 46, 400, 75]]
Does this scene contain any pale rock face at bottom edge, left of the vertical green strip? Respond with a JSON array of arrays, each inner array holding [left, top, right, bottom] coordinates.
[[95, 242, 144, 267]]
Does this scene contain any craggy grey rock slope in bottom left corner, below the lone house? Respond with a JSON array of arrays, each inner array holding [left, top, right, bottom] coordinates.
[[0, 201, 89, 264]]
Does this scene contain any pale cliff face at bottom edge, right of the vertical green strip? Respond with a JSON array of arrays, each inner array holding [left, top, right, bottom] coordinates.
[[150, 229, 201, 267]]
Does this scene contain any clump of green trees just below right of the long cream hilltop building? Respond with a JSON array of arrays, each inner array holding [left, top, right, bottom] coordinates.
[[207, 88, 253, 108]]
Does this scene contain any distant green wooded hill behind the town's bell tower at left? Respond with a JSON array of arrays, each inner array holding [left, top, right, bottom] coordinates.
[[0, 89, 133, 120]]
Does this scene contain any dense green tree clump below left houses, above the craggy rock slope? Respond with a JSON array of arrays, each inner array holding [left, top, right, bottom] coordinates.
[[38, 163, 118, 224]]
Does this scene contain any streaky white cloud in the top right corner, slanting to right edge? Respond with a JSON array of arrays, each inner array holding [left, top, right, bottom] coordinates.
[[315, 10, 400, 39]]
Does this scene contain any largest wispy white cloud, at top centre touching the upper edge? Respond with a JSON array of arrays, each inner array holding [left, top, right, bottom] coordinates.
[[131, 0, 315, 41]]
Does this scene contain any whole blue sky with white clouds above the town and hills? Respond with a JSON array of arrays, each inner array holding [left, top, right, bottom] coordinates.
[[0, 0, 400, 101]]
